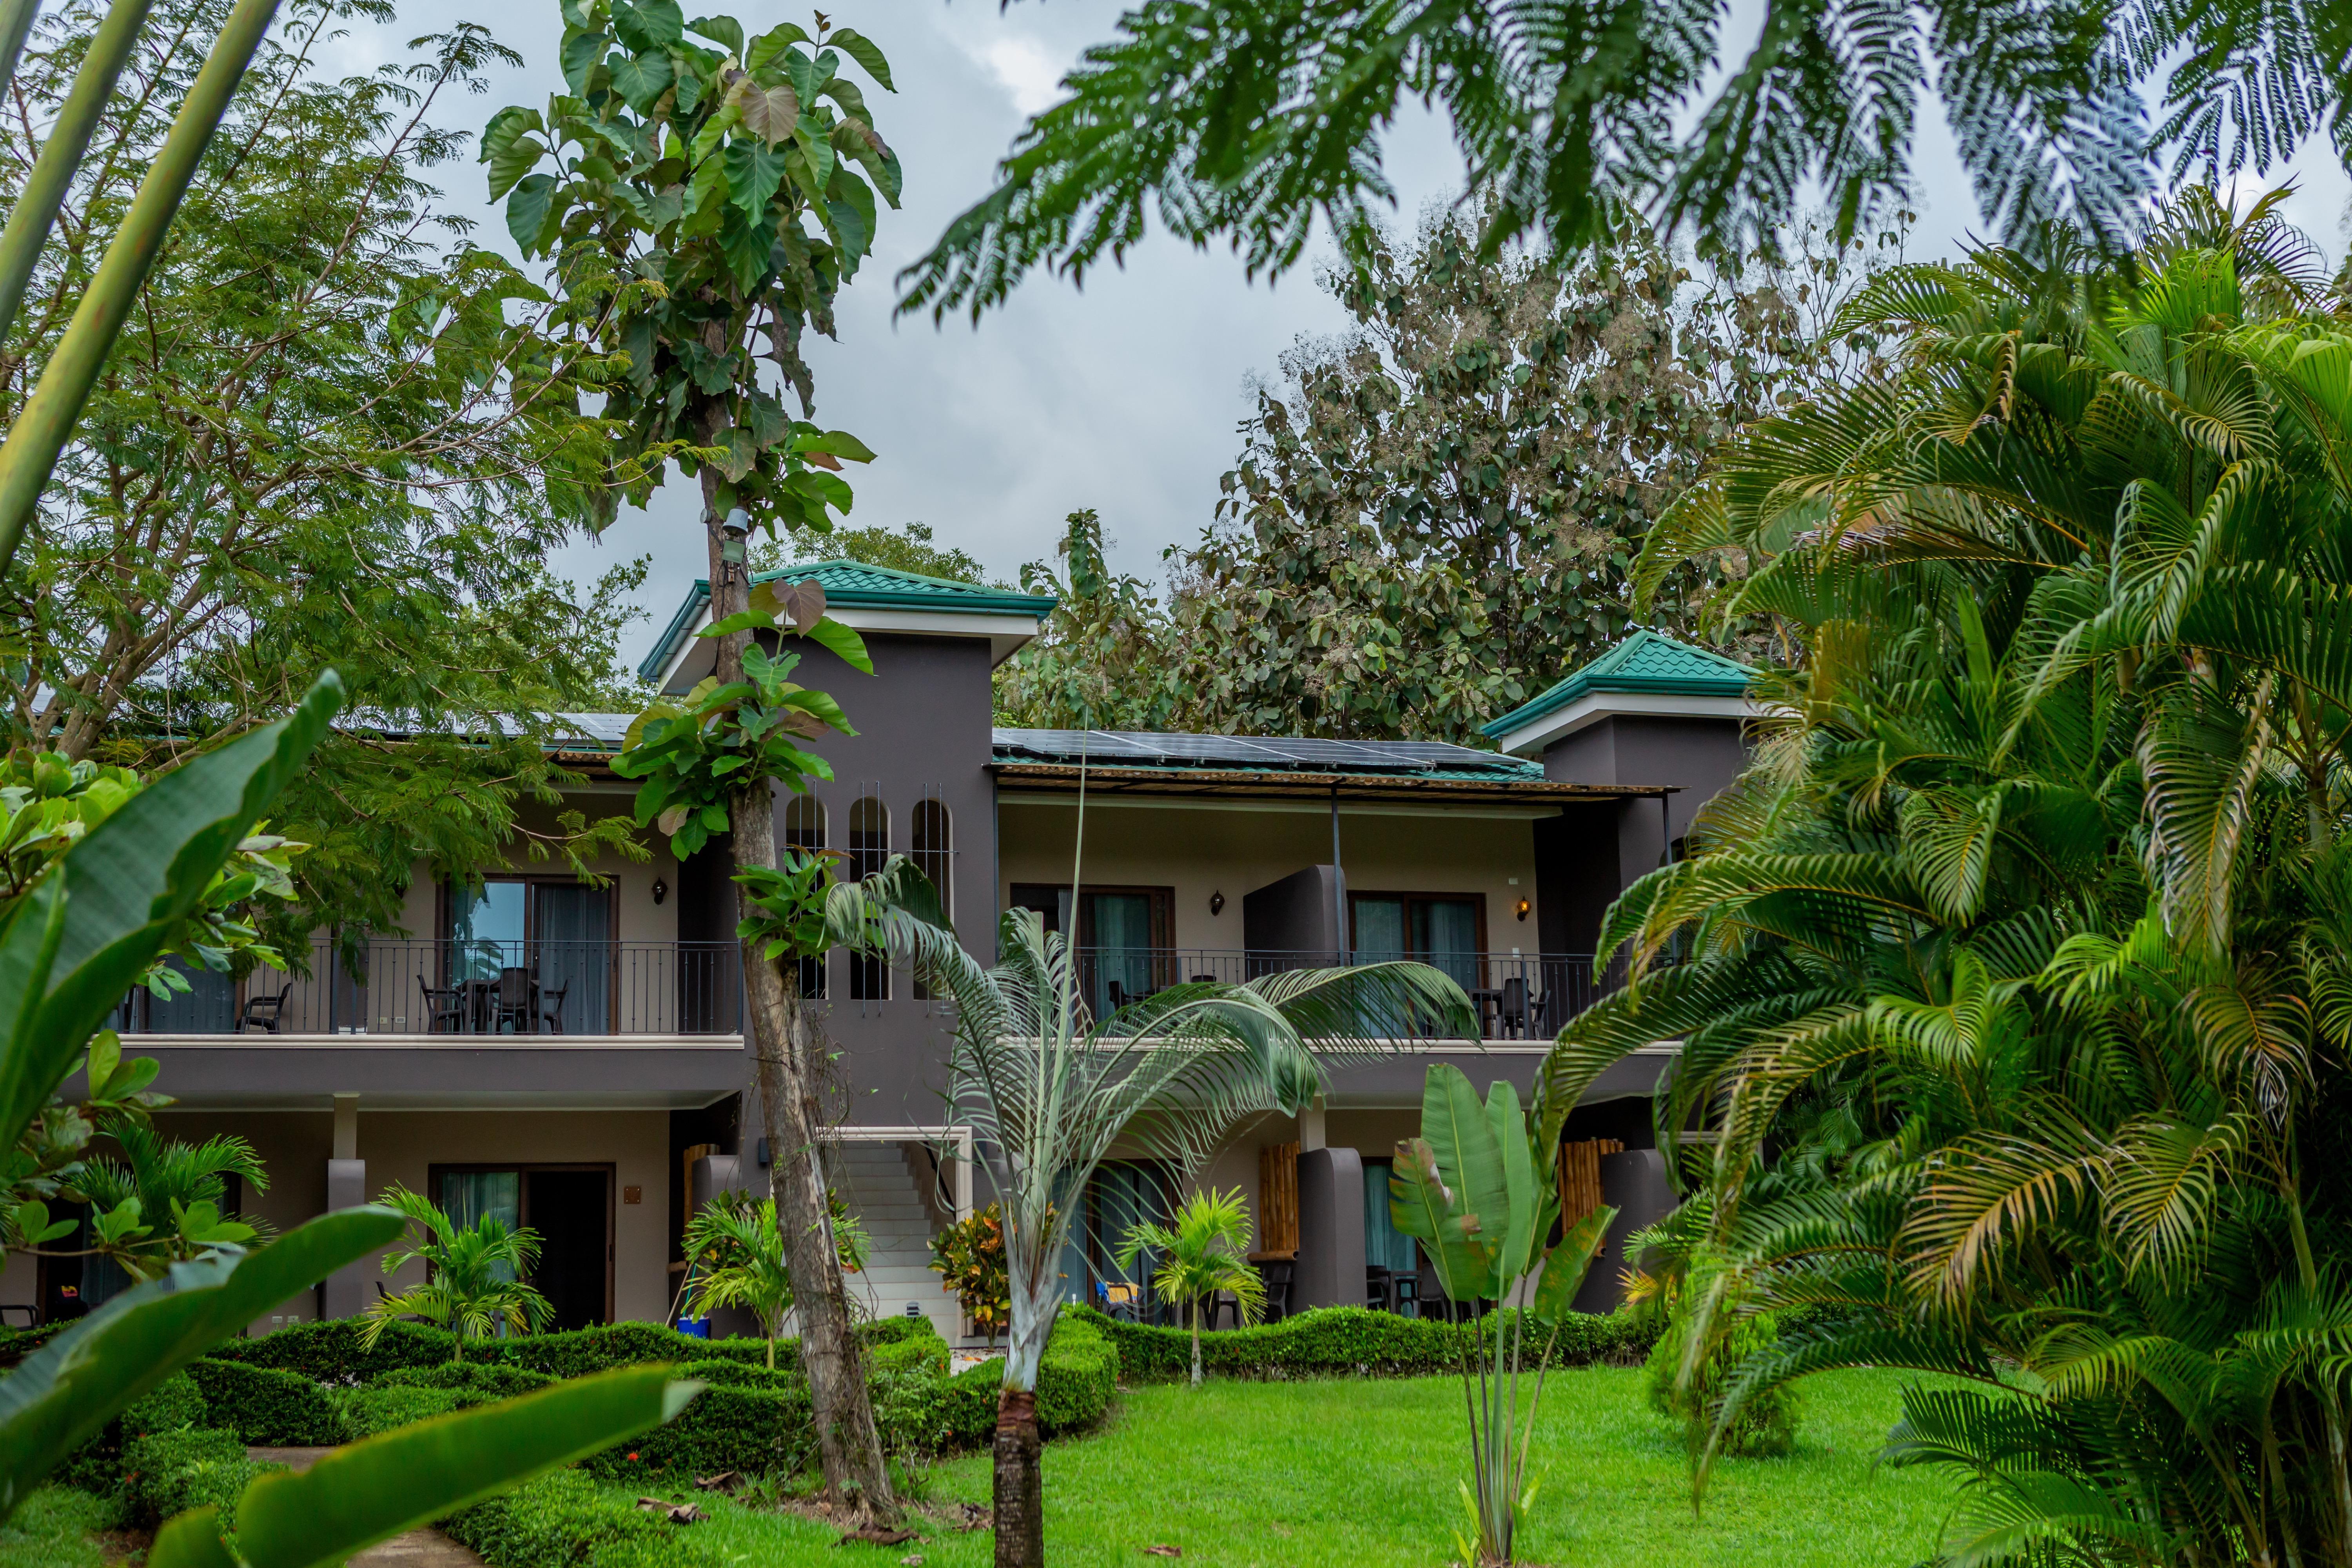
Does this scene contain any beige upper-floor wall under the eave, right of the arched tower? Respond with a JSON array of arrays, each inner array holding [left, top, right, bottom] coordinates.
[[997, 799, 1536, 955]]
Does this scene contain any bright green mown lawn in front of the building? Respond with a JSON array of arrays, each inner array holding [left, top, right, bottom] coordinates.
[[673, 1368, 1952, 1568]]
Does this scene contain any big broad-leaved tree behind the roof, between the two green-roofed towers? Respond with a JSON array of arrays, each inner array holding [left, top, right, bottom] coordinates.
[[1145, 209, 1900, 740]]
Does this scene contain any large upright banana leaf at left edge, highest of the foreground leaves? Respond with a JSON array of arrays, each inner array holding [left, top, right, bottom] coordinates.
[[0, 670, 343, 1147]]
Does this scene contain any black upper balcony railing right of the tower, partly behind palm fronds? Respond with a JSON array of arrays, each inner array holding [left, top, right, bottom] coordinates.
[[1077, 947, 1625, 1039]]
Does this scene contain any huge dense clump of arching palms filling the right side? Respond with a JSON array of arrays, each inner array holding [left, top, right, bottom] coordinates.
[[1541, 191, 2352, 1566]]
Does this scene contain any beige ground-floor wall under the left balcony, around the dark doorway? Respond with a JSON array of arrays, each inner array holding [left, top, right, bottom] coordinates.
[[155, 1105, 677, 1326]]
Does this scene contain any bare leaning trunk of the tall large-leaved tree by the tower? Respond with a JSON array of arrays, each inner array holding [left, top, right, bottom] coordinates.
[[703, 454, 898, 1526]]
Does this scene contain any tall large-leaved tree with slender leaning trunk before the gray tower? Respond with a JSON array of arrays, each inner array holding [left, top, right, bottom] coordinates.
[[482, 0, 898, 1519]]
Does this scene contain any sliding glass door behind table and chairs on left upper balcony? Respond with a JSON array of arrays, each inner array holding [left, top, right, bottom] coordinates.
[[445, 877, 616, 1034]]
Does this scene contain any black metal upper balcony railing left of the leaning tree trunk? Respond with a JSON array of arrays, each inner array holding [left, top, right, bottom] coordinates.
[[115, 938, 743, 1034]]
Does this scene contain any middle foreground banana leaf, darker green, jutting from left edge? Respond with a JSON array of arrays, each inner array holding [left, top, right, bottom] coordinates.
[[0, 1206, 407, 1519]]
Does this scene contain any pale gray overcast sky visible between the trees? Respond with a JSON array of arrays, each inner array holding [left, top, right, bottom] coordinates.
[[318, 0, 2352, 677]]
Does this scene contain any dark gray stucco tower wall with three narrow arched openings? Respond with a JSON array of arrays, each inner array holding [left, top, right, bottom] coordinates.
[[748, 635, 997, 1126]]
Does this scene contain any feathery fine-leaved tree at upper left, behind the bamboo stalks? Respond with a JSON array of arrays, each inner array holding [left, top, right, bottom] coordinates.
[[0, 0, 640, 938]]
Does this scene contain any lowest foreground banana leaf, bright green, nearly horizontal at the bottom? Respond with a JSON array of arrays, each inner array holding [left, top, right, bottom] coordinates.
[[148, 1366, 703, 1568]]
